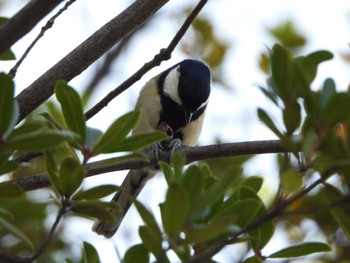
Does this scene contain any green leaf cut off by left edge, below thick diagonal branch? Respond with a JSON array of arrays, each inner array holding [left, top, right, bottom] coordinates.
[[0, 73, 18, 136]]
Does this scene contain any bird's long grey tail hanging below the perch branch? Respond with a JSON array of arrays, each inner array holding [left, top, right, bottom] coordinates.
[[92, 169, 155, 238]]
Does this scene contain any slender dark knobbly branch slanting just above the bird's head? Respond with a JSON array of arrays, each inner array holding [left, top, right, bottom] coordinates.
[[85, 0, 208, 120]]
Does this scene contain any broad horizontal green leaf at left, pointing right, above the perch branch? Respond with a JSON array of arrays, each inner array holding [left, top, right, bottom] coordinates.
[[5, 130, 77, 151]]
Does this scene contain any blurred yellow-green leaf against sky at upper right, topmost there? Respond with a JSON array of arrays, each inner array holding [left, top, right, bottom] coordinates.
[[269, 21, 306, 48]]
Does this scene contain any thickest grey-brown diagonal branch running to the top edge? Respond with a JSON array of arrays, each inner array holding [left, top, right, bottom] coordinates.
[[17, 0, 168, 121]]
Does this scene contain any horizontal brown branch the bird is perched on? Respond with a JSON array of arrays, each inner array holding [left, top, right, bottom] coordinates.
[[8, 140, 288, 191]]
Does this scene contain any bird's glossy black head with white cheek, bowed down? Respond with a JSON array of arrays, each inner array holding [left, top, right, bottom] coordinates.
[[158, 59, 211, 135]]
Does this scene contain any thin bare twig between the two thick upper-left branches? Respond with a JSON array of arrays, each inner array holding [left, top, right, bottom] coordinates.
[[9, 0, 76, 78]]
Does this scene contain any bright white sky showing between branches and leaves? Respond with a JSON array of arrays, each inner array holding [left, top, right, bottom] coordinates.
[[0, 0, 350, 262]]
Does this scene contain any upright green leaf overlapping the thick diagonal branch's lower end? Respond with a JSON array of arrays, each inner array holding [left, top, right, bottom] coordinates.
[[55, 80, 86, 143]]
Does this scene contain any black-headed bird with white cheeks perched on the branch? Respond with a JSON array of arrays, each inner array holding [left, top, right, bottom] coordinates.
[[92, 59, 212, 238]]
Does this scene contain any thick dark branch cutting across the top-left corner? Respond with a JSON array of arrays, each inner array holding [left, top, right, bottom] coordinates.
[[0, 0, 62, 54]]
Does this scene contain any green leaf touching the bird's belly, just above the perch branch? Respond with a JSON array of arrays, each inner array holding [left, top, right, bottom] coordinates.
[[111, 131, 168, 152]]
